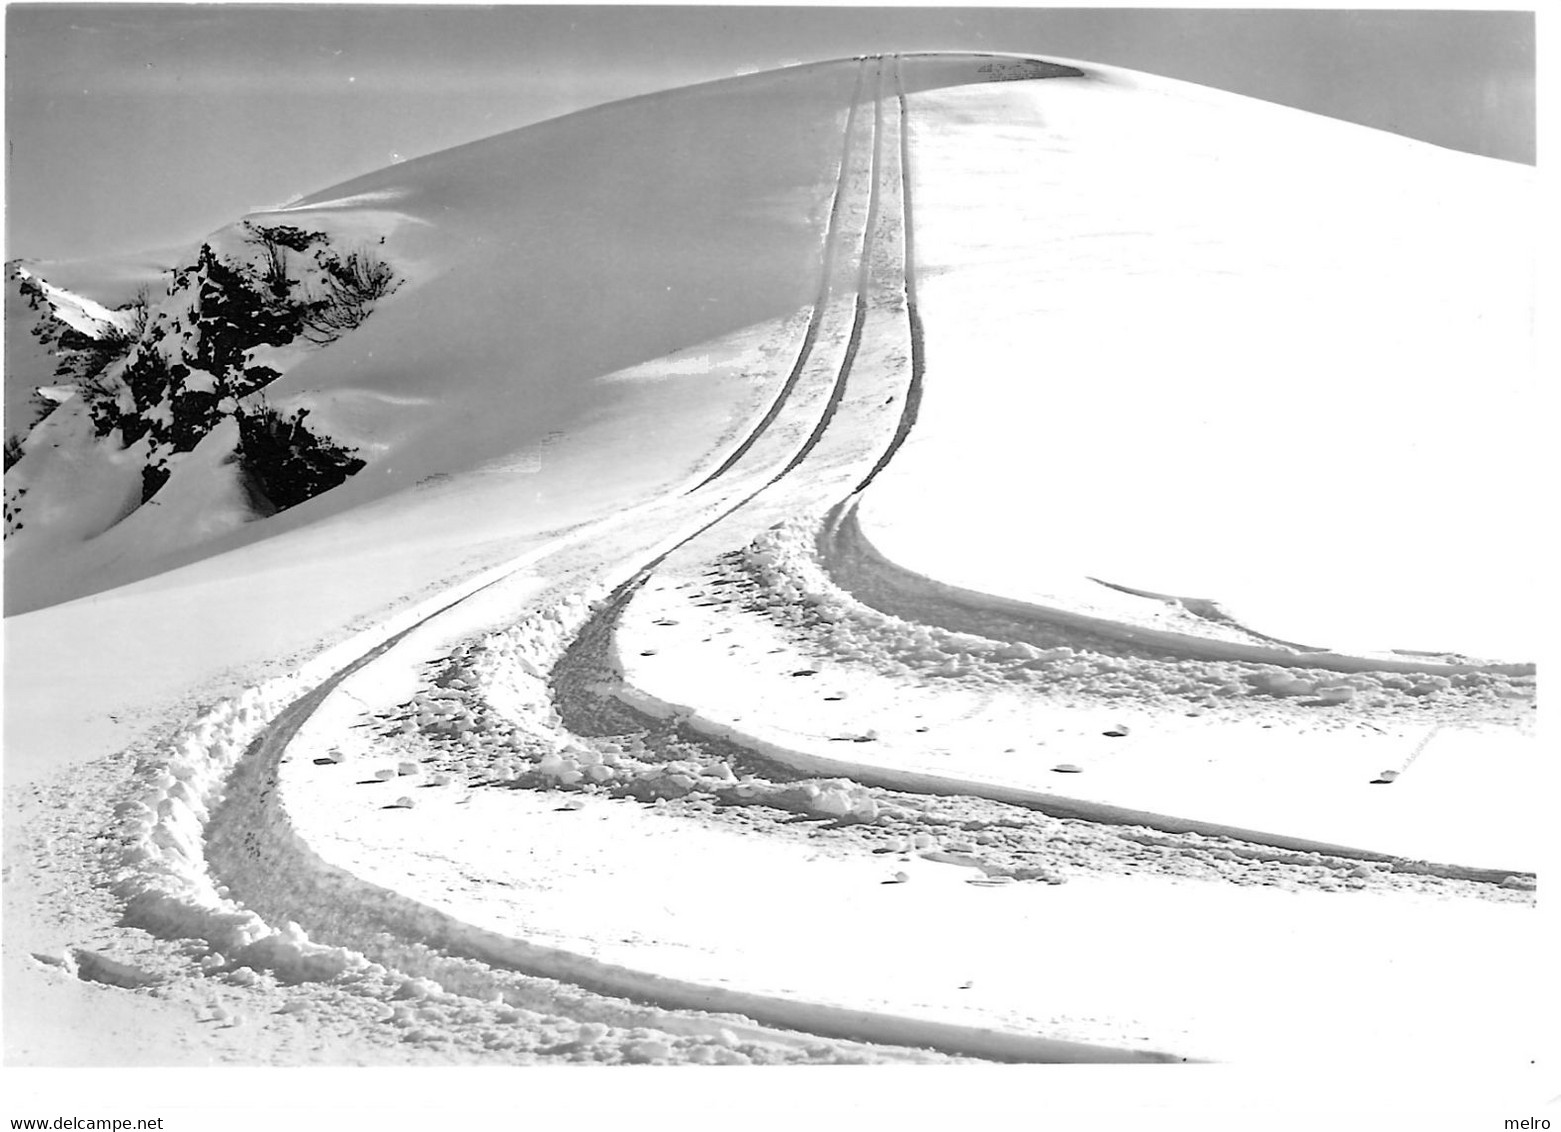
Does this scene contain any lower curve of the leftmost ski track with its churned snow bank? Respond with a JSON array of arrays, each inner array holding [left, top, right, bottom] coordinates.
[[97, 468, 967, 1062]]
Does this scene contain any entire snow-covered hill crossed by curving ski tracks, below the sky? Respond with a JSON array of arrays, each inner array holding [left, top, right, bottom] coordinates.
[[5, 55, 1539, 1085]]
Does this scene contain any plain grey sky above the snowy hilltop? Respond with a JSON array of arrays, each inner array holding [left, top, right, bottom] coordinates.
[[5, 3, 1534, 259]]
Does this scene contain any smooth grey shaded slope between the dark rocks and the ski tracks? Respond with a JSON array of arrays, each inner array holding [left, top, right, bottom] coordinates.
[[8, 56, 852, 610]]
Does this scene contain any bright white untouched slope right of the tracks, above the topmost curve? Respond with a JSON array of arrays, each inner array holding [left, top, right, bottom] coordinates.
[[863, 61, 1539, 660]]
